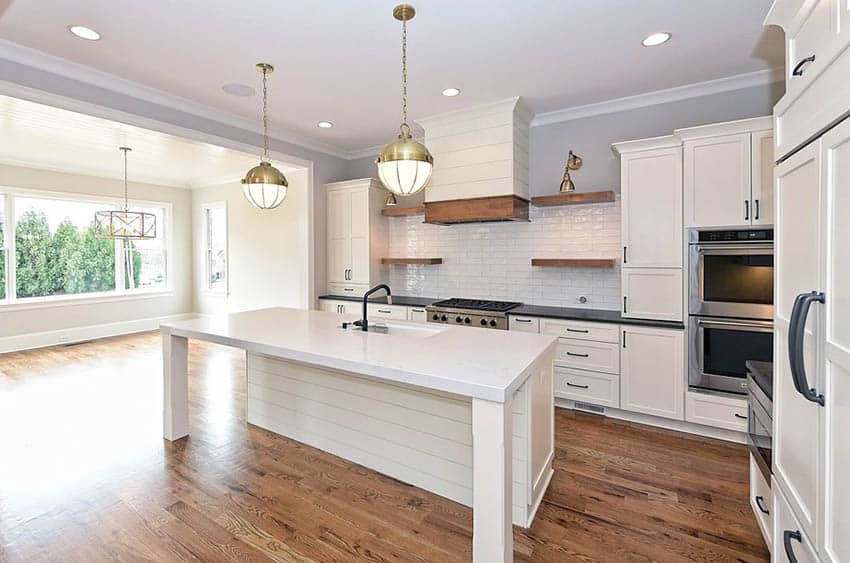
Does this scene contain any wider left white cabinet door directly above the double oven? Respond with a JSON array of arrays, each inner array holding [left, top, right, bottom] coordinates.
[[684, 133, 752, 227]]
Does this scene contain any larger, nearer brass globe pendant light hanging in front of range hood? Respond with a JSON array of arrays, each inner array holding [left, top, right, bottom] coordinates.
[[375, 4, 434, 196]]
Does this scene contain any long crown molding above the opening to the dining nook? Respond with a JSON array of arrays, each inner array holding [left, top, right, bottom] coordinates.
[[0, 39, 352, 160]]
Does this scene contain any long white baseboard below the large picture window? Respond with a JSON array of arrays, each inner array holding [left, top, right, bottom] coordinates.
[[0, 313, 198, 354]]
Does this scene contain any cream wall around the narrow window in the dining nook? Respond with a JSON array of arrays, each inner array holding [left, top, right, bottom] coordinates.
[[192, 170, 313, 314]]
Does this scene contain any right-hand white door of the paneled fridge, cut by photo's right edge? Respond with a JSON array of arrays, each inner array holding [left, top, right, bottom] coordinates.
[[822, 119, 850, 562]]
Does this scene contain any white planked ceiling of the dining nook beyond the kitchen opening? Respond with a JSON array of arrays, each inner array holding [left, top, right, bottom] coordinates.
[[0, 96, 293, 188]]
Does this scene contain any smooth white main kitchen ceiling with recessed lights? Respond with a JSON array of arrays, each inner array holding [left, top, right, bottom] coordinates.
[[0, 0, 783, 151]]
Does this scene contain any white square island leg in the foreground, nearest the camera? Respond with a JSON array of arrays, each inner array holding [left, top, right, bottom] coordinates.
[[472, 399, 514, 563]]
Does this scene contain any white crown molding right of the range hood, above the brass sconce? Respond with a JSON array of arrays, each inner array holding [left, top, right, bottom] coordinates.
[[531, 68, 785, 127]]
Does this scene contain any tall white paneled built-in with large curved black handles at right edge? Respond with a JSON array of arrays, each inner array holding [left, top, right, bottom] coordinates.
[[766, 0, 850, 563]]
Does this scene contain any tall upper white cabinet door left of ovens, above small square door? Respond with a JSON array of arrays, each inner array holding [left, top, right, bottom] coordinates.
[[620, 147, 682, 268]]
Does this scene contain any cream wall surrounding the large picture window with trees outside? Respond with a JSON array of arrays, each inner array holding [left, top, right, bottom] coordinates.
[[0, 164, 192, 340]]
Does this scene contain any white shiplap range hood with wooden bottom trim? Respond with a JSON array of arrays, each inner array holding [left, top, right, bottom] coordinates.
[[417, 97, 533, 225]]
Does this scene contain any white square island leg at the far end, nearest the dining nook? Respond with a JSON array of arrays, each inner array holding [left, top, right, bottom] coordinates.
[[162, 330, 189, 441]]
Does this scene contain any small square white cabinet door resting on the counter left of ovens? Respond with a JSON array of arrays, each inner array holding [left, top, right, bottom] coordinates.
[[622, 268, 684, 321]]
